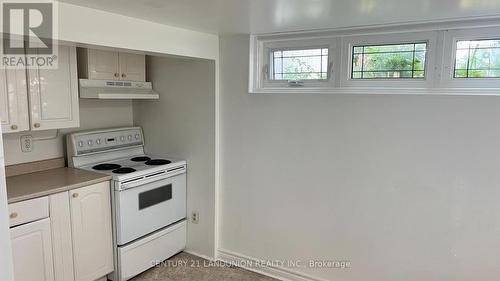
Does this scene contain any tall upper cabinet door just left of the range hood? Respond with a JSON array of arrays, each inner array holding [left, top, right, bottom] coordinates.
[[28, 46, 79, 130]]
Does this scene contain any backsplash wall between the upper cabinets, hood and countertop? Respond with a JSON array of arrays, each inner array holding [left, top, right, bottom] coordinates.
[[3, 99, 133, 165]]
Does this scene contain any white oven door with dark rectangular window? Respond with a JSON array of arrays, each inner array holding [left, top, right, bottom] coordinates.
[[115, 174, 186, 246]]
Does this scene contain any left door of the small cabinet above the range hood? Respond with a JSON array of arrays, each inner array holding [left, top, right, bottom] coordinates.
[[88, 49, 120, 80]]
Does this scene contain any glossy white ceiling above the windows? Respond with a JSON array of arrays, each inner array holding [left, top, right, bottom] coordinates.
[[60, 0, 500, 34]]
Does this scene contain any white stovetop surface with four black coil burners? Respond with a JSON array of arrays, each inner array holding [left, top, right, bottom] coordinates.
[[79, 155, 186, 181]]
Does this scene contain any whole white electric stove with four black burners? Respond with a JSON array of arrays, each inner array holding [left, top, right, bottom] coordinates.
[[67, 127, 187, 281]]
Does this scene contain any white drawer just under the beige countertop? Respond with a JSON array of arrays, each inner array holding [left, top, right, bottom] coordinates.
[[9, 197, 49, 227]]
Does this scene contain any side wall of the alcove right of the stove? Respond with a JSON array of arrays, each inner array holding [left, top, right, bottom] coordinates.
[[134, 57, 215, 257]]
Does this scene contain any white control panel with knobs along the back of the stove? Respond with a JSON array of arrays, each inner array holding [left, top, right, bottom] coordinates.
[[68, 127, 144, 156]]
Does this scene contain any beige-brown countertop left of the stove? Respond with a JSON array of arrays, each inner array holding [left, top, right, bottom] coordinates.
[[7, 167, 111, 203]]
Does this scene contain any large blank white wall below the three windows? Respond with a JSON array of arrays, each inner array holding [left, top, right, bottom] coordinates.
[[219, 36, 500, 281]]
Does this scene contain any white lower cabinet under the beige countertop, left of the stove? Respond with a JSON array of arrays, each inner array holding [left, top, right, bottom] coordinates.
[[9, 182, 113, 281]]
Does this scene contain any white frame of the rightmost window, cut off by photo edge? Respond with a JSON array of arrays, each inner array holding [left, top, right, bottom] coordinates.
[[440, 27, 500, 89]]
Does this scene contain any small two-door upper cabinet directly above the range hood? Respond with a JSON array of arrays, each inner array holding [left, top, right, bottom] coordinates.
[[78, 48, 146, 82]]
